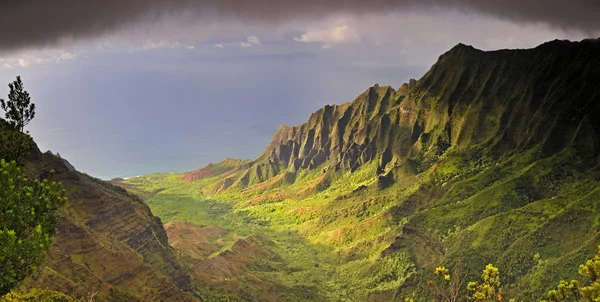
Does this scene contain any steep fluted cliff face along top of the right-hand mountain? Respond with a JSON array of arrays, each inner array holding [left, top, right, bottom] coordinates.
[[195, 40, 600, 193]]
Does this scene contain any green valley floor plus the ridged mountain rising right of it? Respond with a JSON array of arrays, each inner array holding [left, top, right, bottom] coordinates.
[[116, 40, 600, 301]]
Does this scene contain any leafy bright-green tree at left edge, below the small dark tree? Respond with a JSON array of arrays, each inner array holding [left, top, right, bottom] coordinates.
[[0, 159, 65, 296]]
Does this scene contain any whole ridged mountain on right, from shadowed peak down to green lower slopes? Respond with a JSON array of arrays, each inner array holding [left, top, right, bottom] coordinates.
[[182, 40, 600, 301]]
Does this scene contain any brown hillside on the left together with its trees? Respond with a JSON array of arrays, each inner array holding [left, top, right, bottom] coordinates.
[[0, 86, 195, 302]]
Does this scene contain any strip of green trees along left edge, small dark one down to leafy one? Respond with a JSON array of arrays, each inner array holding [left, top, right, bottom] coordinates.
[[0, 77, 65, 296]]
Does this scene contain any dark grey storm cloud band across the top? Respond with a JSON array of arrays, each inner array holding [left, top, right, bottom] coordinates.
[[0, 0, 600, 52]]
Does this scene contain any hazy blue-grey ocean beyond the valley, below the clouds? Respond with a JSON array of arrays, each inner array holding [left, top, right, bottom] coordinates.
[[14, 49, 424, 179]]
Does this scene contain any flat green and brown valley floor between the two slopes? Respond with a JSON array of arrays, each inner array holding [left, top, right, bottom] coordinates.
[[119, 174, 364, 301]]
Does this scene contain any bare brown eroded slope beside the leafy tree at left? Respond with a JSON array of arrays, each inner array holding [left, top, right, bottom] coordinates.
[[23, 148, 194, 301]]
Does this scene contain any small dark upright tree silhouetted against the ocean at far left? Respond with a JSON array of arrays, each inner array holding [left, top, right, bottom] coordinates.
[[0, 76, 35, 133]]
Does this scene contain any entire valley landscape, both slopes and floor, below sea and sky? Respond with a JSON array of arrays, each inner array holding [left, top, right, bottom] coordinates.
[[0, 39, 600, 302]]
